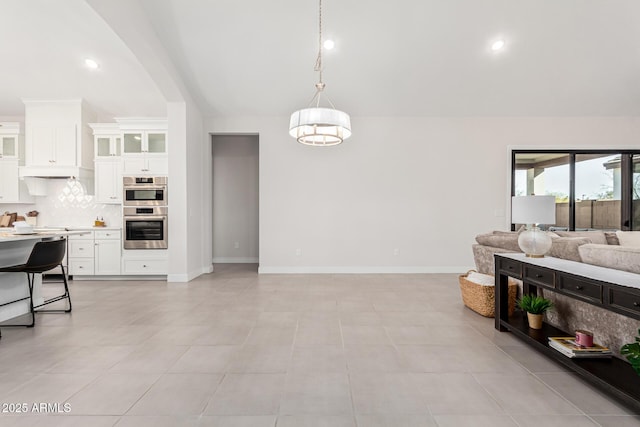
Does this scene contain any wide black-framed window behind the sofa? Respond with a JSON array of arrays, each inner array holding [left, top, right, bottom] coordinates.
[[511, 150, 640, 230]]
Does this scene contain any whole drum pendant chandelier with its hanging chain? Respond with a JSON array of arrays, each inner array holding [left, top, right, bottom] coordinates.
[[289, 0, 351, 147]]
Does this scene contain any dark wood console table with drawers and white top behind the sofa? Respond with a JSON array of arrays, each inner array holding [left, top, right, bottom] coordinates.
[[494, 253, 640, 413]]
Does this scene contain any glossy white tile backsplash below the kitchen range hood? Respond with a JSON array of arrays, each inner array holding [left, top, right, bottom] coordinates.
[[0, 179, 122, 227]]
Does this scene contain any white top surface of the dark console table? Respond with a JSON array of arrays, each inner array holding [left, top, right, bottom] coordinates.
[[496, 253, 640, 289]]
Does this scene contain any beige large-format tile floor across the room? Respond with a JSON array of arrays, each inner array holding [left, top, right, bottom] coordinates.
[[0, 265, 640, 427]]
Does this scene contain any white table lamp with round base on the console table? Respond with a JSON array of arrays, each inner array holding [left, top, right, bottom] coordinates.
[[511, 196, 556, 258]]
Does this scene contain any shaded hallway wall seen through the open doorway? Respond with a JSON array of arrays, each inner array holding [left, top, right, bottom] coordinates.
[[213, 135, 258, 263]]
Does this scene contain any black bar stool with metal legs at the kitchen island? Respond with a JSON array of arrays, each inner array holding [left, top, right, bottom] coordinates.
[[0, 239, 71, 337]]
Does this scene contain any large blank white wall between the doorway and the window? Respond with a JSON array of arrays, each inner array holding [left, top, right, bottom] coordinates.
[[205, 117, 640, 273]]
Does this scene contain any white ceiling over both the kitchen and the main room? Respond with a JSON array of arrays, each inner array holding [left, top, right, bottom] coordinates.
[[0, 0, 640, 116]]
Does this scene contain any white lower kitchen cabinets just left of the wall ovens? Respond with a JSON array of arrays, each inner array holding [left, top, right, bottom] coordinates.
[[68, 229, 122, 276]]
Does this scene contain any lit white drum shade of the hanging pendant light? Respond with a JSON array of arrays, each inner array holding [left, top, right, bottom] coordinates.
[[289, 107, 351, 146]]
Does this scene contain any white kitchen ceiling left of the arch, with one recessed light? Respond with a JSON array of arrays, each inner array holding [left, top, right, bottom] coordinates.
[[0, 0, 167, 120]]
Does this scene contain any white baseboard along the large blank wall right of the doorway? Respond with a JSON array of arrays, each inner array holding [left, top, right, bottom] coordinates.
[[258, 266, 473, 274]]
